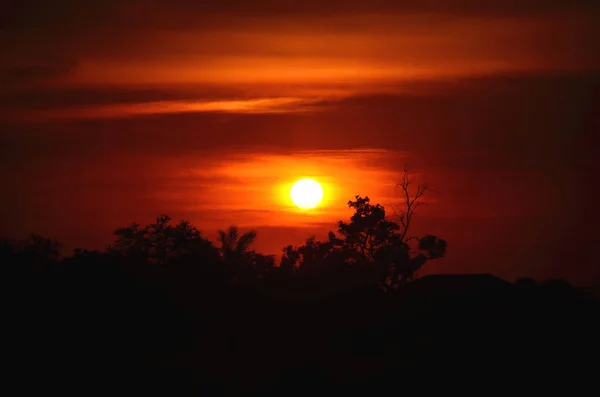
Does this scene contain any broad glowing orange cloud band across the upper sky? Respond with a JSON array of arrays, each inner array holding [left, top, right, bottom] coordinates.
[[54, 14, 598, 86]]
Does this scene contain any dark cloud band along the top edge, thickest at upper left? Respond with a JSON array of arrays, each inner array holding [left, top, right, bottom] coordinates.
[[0, 0, 600, 59]]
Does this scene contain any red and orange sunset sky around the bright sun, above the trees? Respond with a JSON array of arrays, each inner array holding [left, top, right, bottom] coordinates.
[[0, 0, 600, 283]]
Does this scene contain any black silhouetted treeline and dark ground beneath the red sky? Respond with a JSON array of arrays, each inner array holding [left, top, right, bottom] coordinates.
[[0, 169, 600, 395]]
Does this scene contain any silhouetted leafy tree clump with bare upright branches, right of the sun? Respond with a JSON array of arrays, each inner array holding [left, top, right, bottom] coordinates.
[[282, 168, 446, 289]]
